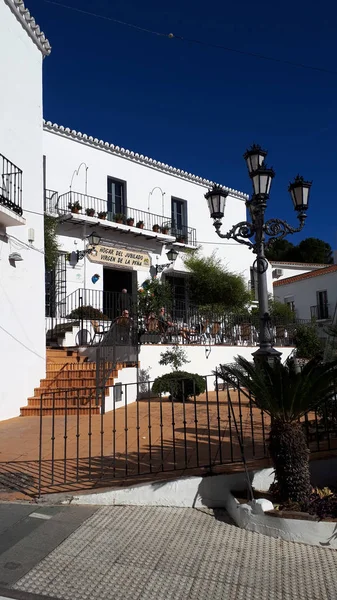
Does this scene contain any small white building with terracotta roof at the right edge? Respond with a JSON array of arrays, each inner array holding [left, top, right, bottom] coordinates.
[[274, 265, 337, 321]]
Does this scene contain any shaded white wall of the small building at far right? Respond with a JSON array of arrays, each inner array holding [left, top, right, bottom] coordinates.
[[274, 272, 337, 319]]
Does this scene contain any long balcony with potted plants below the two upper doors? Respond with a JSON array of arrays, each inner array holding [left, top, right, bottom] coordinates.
[[46, 190, 196, 246]]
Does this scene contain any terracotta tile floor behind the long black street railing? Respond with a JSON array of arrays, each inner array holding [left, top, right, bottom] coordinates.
[[0, 391, 337, 500]]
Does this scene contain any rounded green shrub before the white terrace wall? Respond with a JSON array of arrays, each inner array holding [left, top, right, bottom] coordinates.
[[152, 371, 206, 402]]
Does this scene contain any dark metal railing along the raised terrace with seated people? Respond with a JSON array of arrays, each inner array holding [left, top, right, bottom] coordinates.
[[46, 289, 311, 346]]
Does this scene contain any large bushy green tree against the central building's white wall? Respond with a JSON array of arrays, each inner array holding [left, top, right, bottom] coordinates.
[[185, 253, 250, 312]]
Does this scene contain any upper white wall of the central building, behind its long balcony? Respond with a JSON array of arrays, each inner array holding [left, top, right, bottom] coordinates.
[[44, 130, 253, 281]]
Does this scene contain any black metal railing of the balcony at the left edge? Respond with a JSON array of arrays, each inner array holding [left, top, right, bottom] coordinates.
[[0, 154, 23, 216]]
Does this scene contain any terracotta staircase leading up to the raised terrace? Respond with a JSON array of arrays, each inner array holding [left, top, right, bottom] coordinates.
[[20, 348, 131, 417]]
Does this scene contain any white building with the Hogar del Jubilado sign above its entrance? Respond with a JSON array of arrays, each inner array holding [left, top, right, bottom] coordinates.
[[44, 122, 252, 330]]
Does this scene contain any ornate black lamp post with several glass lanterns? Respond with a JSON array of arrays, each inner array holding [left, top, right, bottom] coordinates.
[[205, 144, 311, 363]]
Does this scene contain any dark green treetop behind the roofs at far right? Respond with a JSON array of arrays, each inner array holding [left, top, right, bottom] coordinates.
[[266, 238, 333, 264]]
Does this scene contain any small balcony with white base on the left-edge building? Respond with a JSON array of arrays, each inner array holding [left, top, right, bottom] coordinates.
[[0, 154, 25, 227]]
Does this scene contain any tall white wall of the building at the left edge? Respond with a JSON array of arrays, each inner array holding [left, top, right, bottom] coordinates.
[[0, 2, 45, 419]]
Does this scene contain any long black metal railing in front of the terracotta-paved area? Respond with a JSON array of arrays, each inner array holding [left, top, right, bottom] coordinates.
[[0, 375, 337, 496]]
